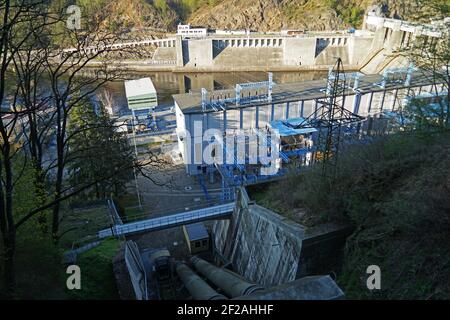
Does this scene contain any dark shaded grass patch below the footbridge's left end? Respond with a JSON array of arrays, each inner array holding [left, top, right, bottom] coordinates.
[[66, 239, 120, 300]]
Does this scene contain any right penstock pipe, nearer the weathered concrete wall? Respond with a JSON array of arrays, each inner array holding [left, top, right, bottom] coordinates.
[[191, 257, 264, 298]]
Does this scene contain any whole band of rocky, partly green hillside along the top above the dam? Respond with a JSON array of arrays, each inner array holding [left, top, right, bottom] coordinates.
[[75, 0, 435, 31]]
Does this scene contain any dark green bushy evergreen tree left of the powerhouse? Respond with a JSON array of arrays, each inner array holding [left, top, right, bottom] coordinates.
[[69, 101, 134, 199]]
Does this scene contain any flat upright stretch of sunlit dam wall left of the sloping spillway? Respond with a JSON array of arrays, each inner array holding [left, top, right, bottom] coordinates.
[[176, 35, 371, 72]]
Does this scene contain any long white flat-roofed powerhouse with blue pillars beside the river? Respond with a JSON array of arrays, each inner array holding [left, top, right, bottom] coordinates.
[[173, 68, 443, 175]]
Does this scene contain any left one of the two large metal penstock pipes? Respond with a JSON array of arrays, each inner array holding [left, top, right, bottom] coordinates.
[[176, 263, 227, 300]]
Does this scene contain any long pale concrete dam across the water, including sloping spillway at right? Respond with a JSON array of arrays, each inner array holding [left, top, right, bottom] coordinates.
[[83, 14, 442, 74]]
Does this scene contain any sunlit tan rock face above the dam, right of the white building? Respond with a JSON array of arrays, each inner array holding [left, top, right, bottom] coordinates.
[[188, 0, 433, 31]]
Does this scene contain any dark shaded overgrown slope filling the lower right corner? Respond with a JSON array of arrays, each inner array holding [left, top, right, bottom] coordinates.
[[250, 132, 450, 299]]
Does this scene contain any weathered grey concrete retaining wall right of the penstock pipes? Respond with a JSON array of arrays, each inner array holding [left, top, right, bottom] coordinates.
[[212, 188, 349, 299]]
